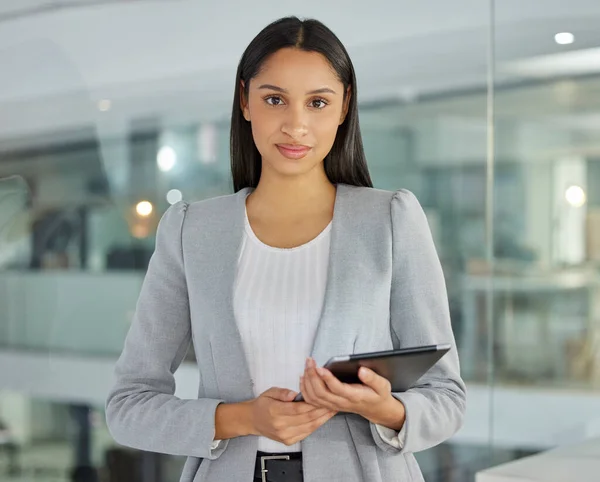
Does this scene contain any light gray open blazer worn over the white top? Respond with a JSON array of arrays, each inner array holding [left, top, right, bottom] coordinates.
[[106, 184, 465, 482]]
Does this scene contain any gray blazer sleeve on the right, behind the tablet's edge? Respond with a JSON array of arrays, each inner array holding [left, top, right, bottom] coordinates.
[[371, 190, 466, 453]]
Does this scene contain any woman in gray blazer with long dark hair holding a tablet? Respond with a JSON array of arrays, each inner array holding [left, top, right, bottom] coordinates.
[[107, 17, 465, 482]]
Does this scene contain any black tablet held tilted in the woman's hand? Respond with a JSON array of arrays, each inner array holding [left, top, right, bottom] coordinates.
[[294, 344, 451, 402]]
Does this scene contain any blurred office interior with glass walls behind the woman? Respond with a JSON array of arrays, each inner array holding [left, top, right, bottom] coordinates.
[[0, 0, 600, 482]]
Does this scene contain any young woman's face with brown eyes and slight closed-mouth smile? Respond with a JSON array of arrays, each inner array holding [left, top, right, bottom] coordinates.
[[242, 48, 350, 180]]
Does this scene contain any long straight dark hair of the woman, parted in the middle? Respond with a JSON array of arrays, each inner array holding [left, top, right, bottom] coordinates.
[[230, 17, 373, 192]]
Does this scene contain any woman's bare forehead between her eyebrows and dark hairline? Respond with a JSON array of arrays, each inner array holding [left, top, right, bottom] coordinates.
[[254, 48, 342, 90]]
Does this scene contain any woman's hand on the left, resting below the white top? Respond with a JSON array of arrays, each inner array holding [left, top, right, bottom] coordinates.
[[251, 388, 337, 446]]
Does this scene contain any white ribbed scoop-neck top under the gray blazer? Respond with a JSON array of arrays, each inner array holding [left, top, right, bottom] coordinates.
[[234, 206, 331, 453]]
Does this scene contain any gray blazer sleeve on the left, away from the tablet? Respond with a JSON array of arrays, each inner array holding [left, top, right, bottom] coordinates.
[[106, 202, 227, 459]]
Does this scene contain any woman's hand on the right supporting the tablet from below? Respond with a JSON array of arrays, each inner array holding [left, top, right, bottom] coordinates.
[[300, 358, 406, 430]]
